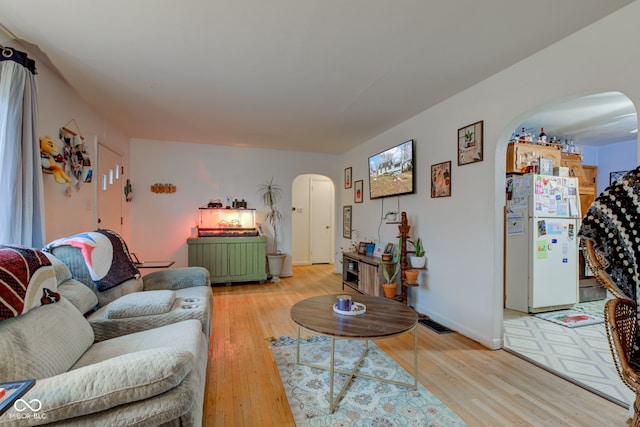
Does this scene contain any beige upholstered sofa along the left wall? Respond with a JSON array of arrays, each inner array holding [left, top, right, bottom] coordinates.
[[0, 239, 212, 426]]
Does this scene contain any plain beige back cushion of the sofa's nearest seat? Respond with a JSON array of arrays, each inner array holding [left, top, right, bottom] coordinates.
[[0, 298, 93, 382]]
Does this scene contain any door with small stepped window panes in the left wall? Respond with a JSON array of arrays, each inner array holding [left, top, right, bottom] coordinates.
[[96, 143, 124, 234]]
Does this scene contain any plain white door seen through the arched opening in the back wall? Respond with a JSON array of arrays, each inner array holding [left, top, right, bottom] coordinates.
[[310, 179, 333, 264]]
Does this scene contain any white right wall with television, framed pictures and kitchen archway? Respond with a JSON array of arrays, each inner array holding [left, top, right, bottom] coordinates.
[[340, 2, 640, 348]]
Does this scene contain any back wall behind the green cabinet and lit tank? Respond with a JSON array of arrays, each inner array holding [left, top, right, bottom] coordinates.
[[129, 139, 342, 277]]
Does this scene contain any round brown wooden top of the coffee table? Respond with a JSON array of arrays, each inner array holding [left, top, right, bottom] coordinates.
[[290, 294, 418, 339]]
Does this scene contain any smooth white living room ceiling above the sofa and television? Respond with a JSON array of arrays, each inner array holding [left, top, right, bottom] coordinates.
[[0, 0, 632, 153]]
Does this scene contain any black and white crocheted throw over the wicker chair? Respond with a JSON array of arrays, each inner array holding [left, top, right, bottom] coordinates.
[[578, 166, 640, 301]]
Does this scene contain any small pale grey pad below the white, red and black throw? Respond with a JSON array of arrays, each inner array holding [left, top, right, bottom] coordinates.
[[104, 291, 176, 319]]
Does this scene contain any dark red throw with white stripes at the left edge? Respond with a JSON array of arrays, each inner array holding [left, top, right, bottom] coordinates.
[[0, 245, 60, 321]]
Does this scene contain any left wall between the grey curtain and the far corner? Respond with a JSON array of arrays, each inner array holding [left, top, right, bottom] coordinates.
[[0, 33, 129, 241]]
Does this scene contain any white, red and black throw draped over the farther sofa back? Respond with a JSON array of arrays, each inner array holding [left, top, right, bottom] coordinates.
[[43, 230, 140, 291]]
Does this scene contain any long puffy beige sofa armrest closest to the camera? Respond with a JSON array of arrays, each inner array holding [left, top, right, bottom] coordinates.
[[1, 347, 195, 425]]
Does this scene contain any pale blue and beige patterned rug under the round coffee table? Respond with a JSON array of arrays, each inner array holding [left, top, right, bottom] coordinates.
[[271, 336, 466, 427]]
